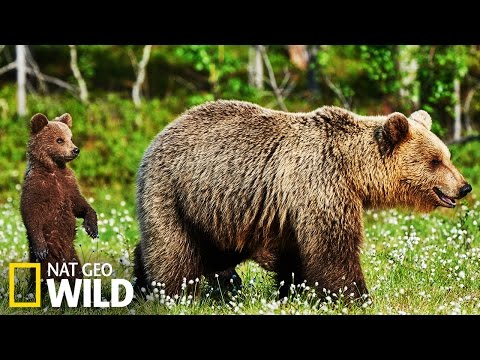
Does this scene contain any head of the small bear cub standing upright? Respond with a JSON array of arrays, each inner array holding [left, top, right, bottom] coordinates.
[[28, 113, 80, 167]]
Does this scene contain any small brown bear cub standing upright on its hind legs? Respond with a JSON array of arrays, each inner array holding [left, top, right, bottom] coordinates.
[[20, 114, 98, 292]]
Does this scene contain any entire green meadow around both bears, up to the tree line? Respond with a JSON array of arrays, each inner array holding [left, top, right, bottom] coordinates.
[[0, 93, 480, 314]]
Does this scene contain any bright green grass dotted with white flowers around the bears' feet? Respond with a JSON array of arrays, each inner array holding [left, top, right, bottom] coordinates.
[[0, 184, 480, 314]]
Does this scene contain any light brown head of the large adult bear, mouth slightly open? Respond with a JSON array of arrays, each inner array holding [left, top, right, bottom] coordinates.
[[375, 110, 472, 212]]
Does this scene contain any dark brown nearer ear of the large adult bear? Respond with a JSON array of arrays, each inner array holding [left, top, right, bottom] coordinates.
[[375, 112, 409, 155]]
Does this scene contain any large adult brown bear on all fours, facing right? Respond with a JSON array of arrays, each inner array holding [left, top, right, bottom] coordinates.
[[135, 101, 472, 297]]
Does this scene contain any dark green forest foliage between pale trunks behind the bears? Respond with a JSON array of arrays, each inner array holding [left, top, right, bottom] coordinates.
[[0, 45, 480, 136]]
